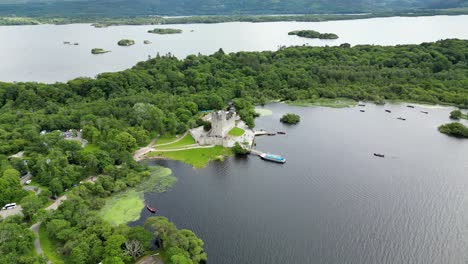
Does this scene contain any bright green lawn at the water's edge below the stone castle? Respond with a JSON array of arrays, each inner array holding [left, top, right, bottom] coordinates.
[[150, 146, 232, 168]]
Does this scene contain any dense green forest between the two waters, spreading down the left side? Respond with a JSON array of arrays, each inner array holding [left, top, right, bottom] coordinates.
[[0, 40, 468, 263]]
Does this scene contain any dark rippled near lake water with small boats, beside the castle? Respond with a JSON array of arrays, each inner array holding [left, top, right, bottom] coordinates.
[[134, 103, 468, 264]]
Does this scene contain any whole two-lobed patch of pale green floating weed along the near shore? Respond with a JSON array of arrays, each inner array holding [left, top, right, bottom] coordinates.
[[99, 167, 176, 226]]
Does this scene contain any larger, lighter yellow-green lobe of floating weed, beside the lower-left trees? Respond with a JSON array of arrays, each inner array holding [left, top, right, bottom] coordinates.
[[99, 189, 145, 226]]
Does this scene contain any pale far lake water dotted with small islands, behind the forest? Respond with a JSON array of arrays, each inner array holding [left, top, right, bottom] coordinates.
[[0, 16, 468, 83]]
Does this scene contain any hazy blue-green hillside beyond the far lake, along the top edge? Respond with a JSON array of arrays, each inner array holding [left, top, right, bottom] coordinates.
[[0, 0, 468, 17]]
